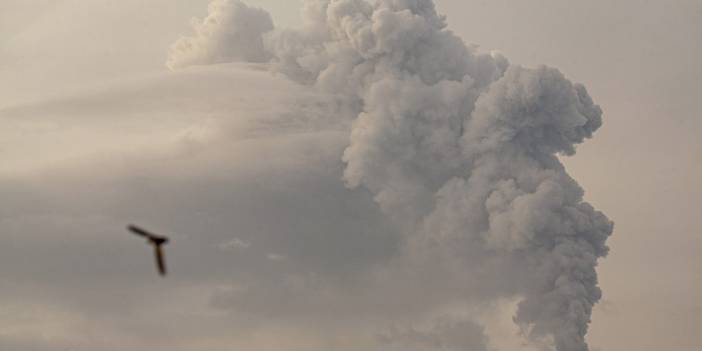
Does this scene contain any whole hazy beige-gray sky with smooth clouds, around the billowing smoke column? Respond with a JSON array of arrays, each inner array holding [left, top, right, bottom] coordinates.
[[0, 0, 702, 351]]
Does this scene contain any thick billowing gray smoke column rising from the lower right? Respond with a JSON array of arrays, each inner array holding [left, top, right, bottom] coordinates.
[[169, 0, 612, 351]]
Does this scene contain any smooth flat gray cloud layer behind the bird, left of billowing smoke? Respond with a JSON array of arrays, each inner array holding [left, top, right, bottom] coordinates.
[[0, 65, 399, 350]]
